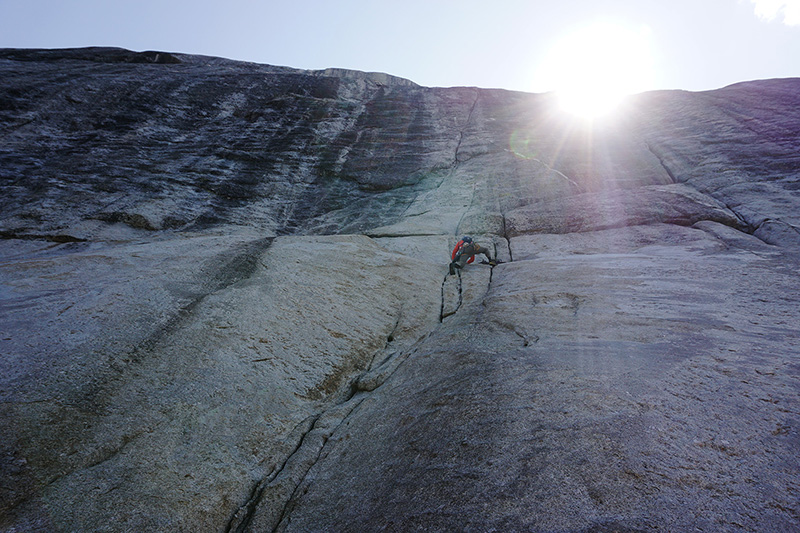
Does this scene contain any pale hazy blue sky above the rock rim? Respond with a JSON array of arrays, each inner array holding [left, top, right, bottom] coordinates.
[[0, 0, 800, 92]]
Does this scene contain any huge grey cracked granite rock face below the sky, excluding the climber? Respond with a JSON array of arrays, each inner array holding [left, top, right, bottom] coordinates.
[[0, 48, 800, 531]]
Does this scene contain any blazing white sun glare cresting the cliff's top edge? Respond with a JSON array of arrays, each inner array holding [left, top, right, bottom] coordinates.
[[538, 21, 654, 119]]
